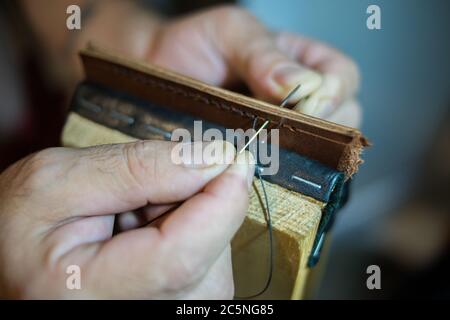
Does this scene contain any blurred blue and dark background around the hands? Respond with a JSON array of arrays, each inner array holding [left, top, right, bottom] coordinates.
[[0, 0, 450, 299]]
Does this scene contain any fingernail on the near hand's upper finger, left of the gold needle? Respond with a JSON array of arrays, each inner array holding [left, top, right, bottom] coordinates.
[[176, 140, 236, 169]]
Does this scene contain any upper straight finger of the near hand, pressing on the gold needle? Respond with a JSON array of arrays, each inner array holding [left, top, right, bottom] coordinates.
[[40, 141, 235, 220]]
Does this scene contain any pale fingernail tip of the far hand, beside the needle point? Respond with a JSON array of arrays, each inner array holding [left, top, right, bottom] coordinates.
[[272, 64, 322, 101]]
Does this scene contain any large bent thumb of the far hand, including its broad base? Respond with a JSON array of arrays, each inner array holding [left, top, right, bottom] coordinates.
[[149, 6, 321, 102]]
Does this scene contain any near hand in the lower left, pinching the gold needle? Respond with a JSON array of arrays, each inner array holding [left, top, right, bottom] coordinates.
[[0, 141, 254, 299]]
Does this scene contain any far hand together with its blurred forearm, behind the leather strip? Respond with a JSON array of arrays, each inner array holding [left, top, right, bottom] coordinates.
[[22, 0, 361, 127]]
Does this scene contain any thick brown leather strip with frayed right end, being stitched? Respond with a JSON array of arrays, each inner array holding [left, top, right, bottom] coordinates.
[[81, 46, 369, 177]]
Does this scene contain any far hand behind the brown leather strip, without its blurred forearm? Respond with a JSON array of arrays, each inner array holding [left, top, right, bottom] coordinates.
[[145, 6, 361, 127]]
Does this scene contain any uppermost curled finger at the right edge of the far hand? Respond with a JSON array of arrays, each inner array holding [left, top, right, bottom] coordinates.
[[277, 33, 359, 111]]
